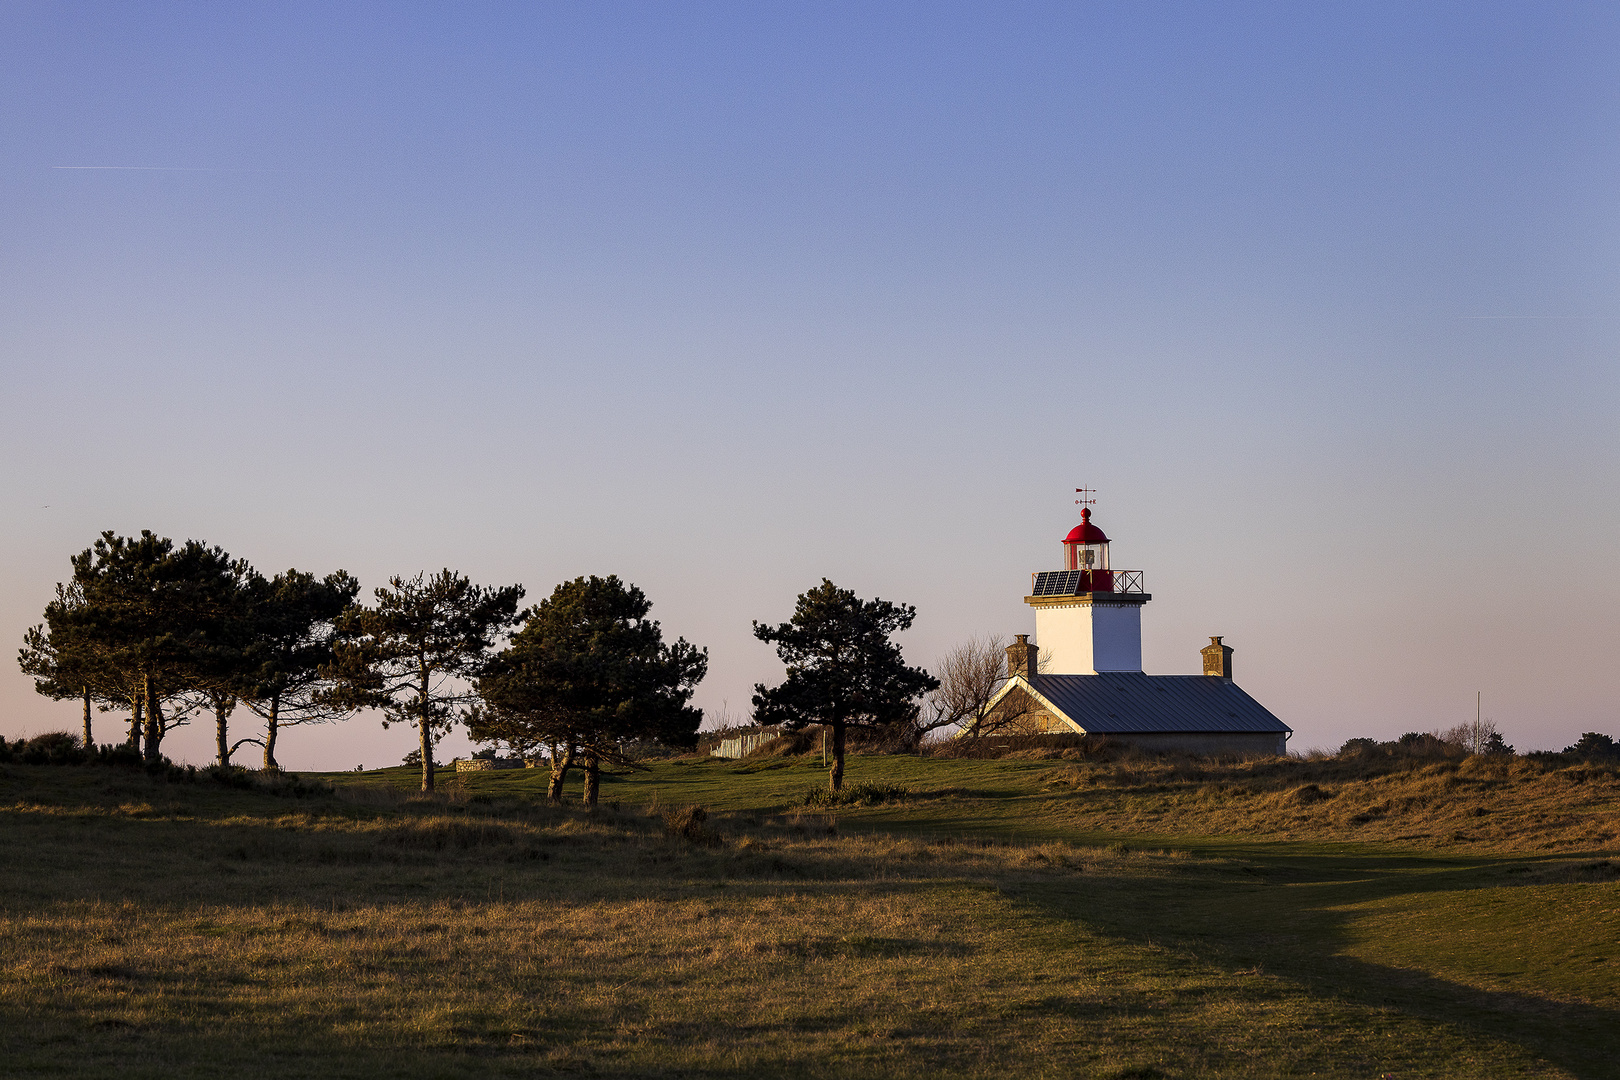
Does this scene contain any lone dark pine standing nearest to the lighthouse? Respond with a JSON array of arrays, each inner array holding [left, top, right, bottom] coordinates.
[[753, 578, 940, 792]]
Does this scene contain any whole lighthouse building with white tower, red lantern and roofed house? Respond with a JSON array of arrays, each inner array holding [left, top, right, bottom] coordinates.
[[975, 507, 1293, 756]]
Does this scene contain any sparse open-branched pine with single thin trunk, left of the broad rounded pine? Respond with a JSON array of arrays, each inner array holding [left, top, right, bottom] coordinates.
[[327, 570, 523, 792]]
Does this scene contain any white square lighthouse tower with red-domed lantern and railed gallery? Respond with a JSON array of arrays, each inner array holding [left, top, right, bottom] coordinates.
[[1024, 507, 1153, 675]]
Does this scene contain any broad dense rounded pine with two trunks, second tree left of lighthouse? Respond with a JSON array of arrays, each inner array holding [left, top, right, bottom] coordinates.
[[468, 575, 708, 806]]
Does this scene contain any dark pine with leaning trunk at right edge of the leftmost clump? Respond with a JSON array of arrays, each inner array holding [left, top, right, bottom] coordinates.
[[236, 570, 360, 771]]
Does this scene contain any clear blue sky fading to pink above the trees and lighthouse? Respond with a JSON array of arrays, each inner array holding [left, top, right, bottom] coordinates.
[[0, 0, 1620, 767]]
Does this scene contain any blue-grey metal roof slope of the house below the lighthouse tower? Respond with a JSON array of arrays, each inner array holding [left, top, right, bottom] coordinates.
[[1029, 672, 1294, 735]]
